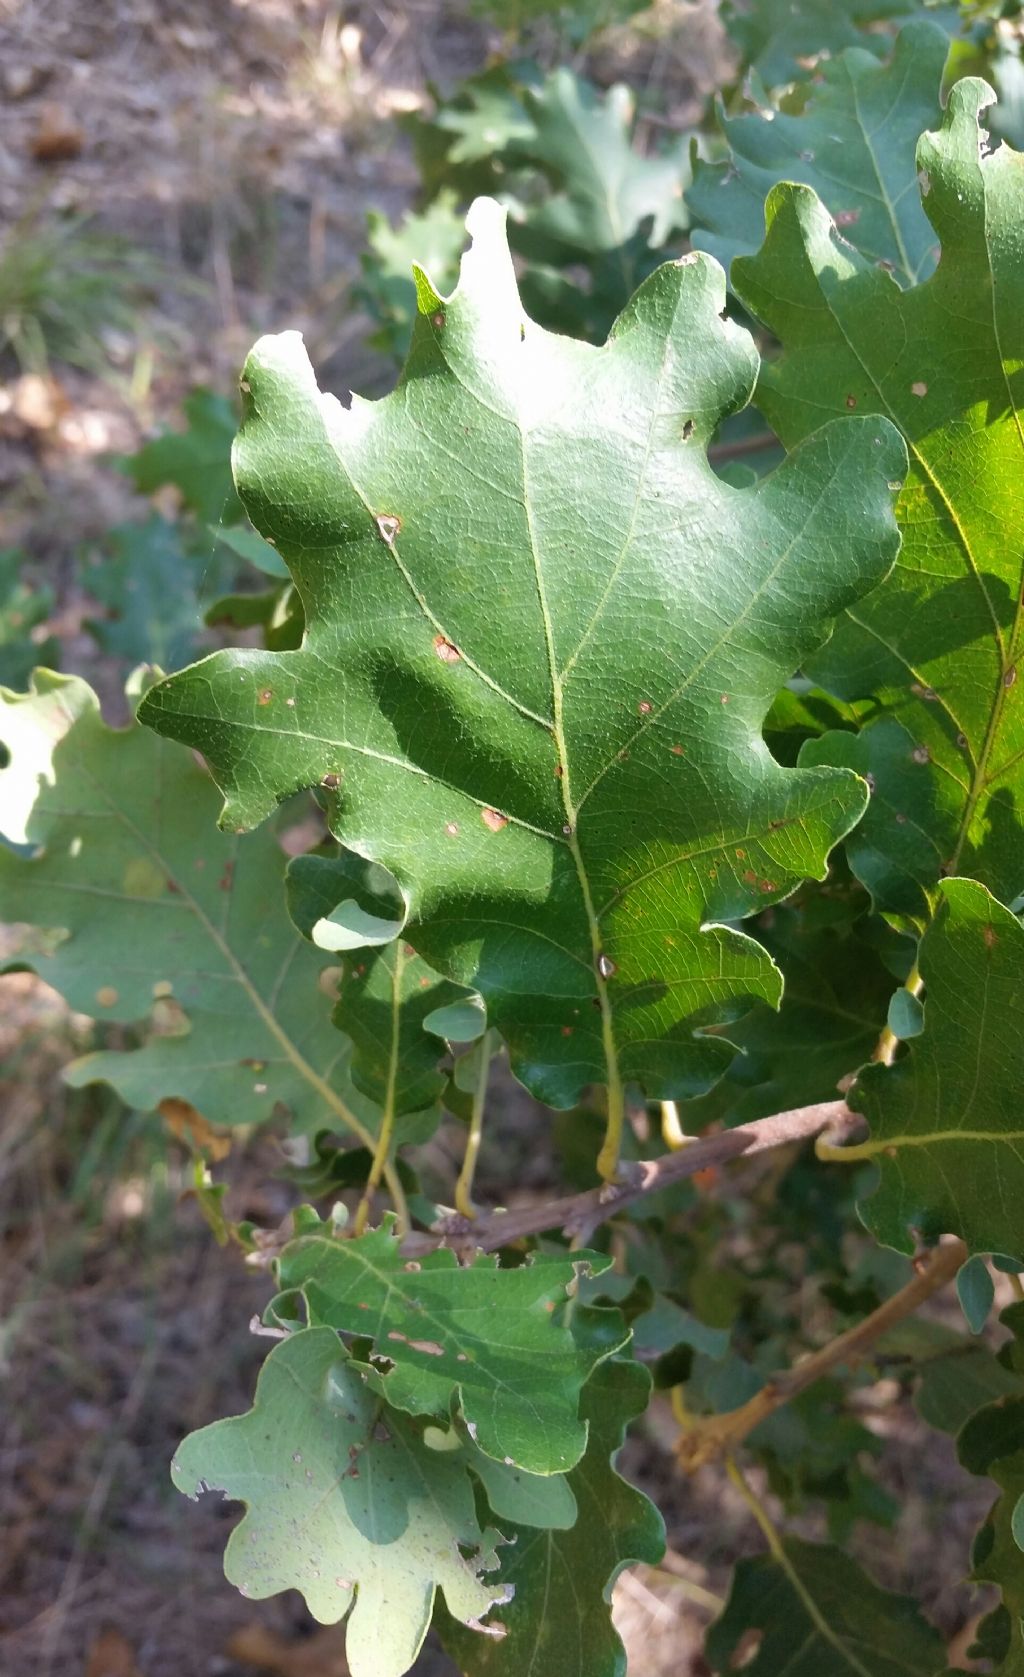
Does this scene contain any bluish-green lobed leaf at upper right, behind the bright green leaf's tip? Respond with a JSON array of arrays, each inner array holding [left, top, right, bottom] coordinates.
[[685, 20, 949, 285]]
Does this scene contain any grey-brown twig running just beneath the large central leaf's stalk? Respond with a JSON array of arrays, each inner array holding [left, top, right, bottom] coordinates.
[[402, 1100, 863, 1256]]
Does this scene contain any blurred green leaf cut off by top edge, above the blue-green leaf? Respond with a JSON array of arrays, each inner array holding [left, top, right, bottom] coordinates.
[[722, 0, 918, 87]]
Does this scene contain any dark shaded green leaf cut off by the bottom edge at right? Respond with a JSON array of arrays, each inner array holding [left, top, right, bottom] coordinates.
[[704, 1538, 945, 1677]]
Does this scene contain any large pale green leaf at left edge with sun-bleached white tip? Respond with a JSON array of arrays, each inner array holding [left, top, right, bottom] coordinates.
[[0, 671, 374, 1134]]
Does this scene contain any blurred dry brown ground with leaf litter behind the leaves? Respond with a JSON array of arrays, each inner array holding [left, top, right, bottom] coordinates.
[[0, 0, 985, 1677]]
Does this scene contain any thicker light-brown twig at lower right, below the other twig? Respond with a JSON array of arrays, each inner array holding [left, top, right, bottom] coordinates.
[[677, 1241, 967, 1472]]
